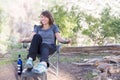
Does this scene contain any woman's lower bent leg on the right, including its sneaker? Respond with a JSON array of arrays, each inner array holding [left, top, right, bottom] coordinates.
[[32, 44, 56, 74]]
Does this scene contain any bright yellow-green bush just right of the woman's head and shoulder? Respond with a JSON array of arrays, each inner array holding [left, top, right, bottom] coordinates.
[[51, 5, 81, 44]]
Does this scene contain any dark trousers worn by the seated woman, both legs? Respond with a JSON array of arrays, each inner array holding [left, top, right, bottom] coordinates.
[[27, 34, 56, 67]]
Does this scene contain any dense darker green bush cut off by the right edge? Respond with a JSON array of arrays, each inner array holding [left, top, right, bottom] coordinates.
[[101, 8, 120, 38]]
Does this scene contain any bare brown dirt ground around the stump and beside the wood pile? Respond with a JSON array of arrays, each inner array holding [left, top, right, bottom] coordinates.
[[0, 54, 120, 80]]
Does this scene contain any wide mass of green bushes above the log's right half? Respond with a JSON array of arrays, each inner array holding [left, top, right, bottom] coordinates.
[[82, 8, 120, 45]]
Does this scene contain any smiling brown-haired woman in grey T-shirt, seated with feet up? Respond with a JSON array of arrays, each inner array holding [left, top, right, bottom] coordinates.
[[19, 11, 70, 74]]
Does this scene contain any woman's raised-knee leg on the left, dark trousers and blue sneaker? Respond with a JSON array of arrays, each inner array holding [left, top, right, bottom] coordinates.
[[25, 34, 42, 69]]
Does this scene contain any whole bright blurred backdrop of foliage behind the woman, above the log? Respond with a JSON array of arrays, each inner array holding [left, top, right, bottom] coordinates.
[[0, 0, 120, 54]]
